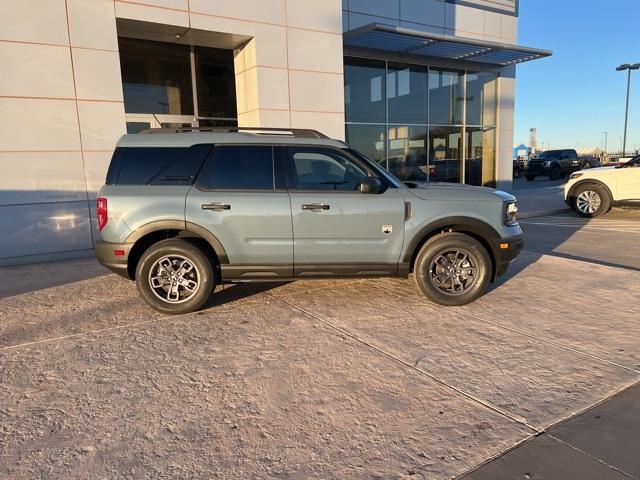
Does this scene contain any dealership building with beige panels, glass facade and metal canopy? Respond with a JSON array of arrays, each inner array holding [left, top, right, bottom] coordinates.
[[0, 0, 550, 265]]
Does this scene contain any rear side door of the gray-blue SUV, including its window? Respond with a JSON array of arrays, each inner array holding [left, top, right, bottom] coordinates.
[[186, 145, 293, 279]]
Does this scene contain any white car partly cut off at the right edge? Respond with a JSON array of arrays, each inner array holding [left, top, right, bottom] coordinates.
[[564, 156, 640, 217]]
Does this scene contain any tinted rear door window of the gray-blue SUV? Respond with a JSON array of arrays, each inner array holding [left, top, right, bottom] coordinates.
[[196, 145, 275, 190]]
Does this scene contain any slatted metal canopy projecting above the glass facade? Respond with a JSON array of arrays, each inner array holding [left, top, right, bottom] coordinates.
[[343, 23, 553, 67]]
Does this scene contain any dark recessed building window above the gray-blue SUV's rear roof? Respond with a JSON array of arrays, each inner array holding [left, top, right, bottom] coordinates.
[[118, 37, 237, 133]]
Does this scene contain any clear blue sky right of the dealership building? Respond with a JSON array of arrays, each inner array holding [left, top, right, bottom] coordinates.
[[514, 0, 640, 151]]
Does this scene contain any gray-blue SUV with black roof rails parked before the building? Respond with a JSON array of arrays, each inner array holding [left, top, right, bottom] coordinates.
[[96, 128, 523, 314]]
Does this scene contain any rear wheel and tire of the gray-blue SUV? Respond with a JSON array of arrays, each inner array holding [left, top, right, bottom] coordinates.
[[136, 238, 216, 315]]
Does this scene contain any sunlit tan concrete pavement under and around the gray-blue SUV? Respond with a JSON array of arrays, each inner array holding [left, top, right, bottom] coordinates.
[[0, 211, 640, 479]]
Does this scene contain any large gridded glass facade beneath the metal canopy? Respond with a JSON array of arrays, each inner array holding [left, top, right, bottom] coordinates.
[[344, 57, 498, 186]]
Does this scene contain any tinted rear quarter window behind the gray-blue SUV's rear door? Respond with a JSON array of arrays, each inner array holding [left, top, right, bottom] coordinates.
[[107, 145, 211, 185]]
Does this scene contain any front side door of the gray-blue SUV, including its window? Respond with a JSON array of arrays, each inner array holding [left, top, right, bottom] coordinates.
[[281, 147, 404, 277]]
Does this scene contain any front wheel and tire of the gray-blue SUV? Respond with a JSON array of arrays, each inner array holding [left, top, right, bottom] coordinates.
[[414, 232, 492, 306]]
